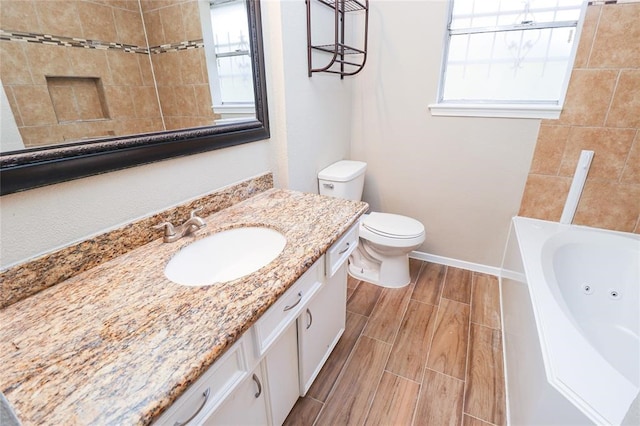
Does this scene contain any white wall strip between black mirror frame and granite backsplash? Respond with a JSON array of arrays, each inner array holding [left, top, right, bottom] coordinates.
[[0, 141, 269, 268]]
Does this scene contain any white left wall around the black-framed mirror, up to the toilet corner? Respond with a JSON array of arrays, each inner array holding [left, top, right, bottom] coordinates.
[[0, 0, 351, 268]]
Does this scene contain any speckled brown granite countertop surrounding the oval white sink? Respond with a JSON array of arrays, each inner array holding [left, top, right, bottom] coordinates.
[[0, 189, 367, 425]]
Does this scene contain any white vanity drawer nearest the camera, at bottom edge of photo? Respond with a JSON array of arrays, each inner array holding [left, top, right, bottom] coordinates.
[[155, 337, 250, 426]]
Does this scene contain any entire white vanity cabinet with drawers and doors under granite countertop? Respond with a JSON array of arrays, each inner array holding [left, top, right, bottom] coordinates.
[[156, 223, 358, 426]]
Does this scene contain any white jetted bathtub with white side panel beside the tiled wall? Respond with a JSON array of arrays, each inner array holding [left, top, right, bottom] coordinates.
[[501, 217, 640, 425]]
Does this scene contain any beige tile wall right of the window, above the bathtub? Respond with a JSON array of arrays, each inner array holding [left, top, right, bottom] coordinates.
[[519, 3, 640, 233]]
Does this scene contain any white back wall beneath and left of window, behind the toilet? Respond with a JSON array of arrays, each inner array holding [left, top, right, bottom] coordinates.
[[351, 0, 540, 266]]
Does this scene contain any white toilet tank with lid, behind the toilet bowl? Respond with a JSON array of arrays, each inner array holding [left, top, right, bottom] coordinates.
[[318, 160, 367, 200]]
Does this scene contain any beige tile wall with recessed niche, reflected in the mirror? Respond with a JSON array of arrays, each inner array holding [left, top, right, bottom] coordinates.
[[0, 0, 215, 147]]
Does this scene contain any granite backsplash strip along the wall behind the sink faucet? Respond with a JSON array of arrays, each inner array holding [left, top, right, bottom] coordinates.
[[0, 173, 273, 309]]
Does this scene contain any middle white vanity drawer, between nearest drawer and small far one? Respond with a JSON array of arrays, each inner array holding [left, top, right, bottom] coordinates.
[[252, 256, 324, 357]]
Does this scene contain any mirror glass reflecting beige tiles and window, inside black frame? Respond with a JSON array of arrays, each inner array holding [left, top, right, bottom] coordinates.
[[0, 0, 255, 152]]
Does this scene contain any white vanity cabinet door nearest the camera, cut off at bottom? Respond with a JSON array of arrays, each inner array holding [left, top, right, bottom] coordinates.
[[203, 364, 269, 426]]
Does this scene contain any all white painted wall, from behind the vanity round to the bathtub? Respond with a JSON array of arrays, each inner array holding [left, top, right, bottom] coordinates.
[[0, 0, 539, 267]]
